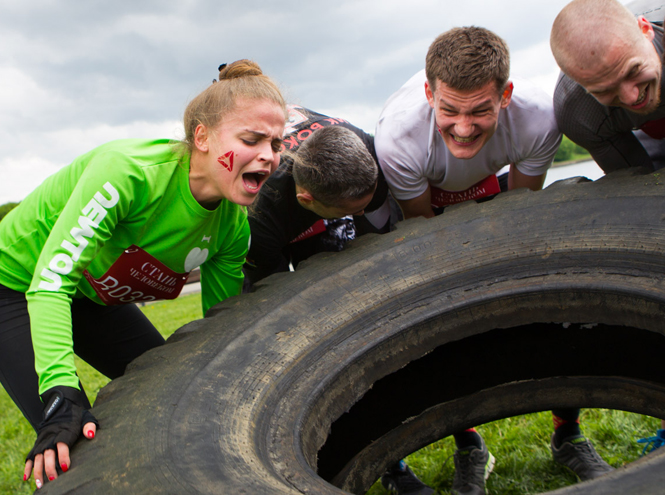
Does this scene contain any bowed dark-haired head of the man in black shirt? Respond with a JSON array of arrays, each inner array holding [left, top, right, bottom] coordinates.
[[292, 126, 379, 218]]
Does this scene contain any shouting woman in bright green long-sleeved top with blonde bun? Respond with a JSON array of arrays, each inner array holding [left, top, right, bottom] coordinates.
[[0, 60, 286, 488]]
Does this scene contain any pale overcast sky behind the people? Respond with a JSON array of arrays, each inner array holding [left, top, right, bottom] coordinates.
[[0, 0, 636, 204]]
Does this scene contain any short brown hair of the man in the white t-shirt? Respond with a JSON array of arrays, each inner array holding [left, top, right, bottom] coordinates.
[[425, 26, 510, 93]]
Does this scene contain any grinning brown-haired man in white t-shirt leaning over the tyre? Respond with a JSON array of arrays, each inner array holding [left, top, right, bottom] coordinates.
[[375, 27, 561, 218]]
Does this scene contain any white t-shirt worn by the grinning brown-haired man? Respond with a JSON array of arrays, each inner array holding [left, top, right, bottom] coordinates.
[[374, 70, 561, 200]]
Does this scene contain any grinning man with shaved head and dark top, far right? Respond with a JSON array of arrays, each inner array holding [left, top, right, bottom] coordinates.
[[550, 0, 665, 172]]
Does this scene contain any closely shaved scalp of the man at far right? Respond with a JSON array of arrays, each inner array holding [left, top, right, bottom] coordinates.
[[550, 0, 640, 74]]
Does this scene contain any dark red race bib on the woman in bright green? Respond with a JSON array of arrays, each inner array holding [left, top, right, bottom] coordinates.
[[83, 245, 189, 306]]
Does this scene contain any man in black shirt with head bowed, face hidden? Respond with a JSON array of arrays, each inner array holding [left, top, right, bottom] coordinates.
[[244, 106, 391, 291]]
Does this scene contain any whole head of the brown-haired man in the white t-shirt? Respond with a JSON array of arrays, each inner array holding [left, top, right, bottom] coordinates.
[[425, 26, 513, 159]]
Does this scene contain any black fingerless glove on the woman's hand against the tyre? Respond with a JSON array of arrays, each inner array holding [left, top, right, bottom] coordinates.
[[26, 386, 99, 461]]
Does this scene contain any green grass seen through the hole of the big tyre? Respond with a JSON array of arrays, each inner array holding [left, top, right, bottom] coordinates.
[[368, 409, 660, 495]]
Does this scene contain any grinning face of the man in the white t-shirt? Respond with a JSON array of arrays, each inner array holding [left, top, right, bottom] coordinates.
[[425, 81, 513, 160]]
